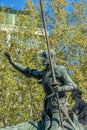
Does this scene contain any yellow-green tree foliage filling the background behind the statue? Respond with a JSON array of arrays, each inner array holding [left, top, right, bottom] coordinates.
[[0, 0, 87, 127]]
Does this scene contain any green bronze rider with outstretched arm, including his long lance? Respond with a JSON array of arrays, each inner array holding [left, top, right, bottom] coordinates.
[[1, 0, 83, 130]]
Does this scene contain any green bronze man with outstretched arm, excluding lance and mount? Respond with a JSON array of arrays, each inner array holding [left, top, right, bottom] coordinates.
[[5, 50, 77, 130]]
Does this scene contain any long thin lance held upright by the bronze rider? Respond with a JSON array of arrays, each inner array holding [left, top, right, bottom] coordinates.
[[39, 0, 63, 128]]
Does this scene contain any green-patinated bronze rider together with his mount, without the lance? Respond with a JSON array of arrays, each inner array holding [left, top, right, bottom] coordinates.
[[2, 50, 84, 130]]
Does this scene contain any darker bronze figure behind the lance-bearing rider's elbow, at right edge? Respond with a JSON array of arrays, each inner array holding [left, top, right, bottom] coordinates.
[[71, 89, 87, 125]]
